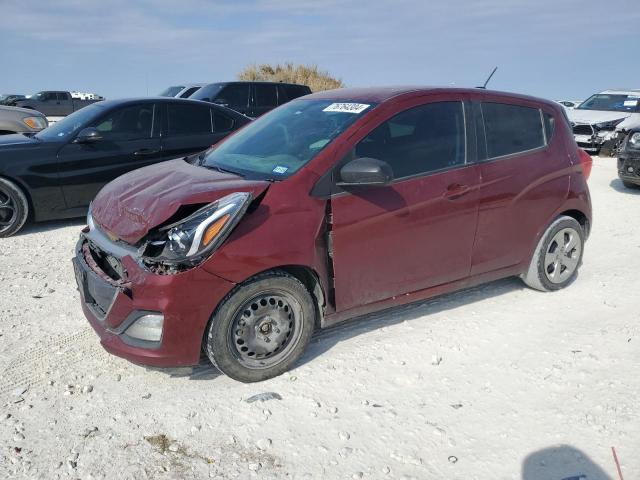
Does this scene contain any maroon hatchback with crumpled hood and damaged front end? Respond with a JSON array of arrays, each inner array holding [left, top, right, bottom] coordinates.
[[74, 88, 591, 382]]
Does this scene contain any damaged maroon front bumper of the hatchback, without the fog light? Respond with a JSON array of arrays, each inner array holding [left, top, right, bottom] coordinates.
[[73, 237, 234, 367]]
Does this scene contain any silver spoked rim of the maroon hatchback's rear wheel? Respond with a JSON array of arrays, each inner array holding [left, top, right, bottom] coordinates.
[[544, 228, 582, 283]]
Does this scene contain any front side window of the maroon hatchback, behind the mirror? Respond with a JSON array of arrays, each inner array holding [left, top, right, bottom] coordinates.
[[355, 102, 466, 178]]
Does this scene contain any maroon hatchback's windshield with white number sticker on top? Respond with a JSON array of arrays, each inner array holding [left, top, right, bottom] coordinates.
[[202, 100, 374, 180]]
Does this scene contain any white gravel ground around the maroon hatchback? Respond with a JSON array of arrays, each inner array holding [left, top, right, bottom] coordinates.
[[0, 159, 640, 480]]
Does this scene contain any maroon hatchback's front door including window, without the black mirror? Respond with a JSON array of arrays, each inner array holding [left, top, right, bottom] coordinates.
[[331, 96, 479, 311]]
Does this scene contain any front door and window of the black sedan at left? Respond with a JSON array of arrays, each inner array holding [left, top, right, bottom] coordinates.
[[58, 103, 161, 208]]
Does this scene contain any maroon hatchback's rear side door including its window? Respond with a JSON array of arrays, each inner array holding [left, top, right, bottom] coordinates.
[[471, 97, 569, 275]]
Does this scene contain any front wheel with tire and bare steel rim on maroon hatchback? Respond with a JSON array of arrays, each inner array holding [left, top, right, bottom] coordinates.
[[204, 271, 316, 383]]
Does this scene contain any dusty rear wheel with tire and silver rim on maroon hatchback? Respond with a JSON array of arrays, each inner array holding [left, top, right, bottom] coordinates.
[[522, 215, 584, 292]]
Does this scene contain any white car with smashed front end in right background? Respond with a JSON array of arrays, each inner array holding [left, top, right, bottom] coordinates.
[[567, 90, 640, 155]]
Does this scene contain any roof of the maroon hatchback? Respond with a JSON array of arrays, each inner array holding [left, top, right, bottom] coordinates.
[[299, 85, 556, 105]]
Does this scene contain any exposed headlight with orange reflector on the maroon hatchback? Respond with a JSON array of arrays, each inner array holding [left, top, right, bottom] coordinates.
[[142, 192, 251, 265]]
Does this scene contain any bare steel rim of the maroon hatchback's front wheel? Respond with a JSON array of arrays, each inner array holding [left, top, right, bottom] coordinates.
[[228, 290, 303, 369]]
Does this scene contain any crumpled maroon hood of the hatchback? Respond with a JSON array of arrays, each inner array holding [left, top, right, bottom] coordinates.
[[91, 160, 269, 244]]
